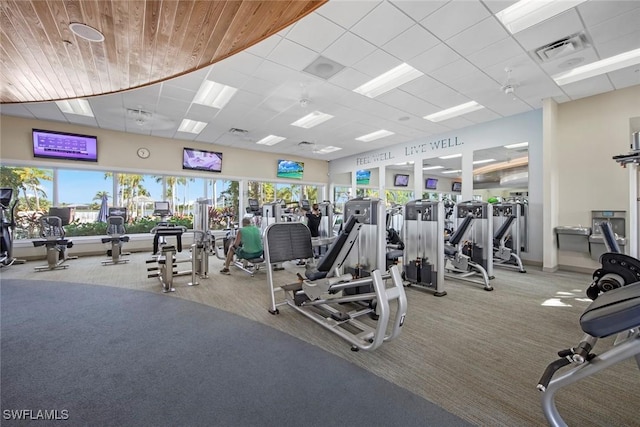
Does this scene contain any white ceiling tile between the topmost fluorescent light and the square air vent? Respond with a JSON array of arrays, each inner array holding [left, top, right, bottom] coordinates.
[[513, 9, 584, 50]]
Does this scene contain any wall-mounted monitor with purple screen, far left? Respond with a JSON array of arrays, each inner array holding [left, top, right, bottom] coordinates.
[[32, 129, 98, 162]]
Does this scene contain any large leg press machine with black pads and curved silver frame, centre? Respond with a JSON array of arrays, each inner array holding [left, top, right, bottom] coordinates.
[[265, 221, 407, 351]]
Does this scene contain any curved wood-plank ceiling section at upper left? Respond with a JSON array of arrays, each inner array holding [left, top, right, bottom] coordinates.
[[0, 0, 327, 103]]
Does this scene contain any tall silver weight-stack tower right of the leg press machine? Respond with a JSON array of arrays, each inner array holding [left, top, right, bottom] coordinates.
[[402, 200, 447, 297]]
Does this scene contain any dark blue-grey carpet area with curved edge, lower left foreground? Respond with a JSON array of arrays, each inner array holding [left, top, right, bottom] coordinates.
[[0, 279, 470, 426]]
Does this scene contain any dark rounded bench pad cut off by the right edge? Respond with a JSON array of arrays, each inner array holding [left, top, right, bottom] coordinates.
[[580, 282, 640, 338]]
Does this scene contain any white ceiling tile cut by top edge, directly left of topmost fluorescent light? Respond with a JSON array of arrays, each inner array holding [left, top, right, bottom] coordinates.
[[420, 1, 490, 40]]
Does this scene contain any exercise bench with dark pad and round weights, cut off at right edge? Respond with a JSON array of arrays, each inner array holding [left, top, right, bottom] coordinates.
[[537, 246, 640, 426]]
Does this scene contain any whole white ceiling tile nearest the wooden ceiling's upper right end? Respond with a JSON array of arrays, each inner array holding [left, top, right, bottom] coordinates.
[[287, 13, 345, 52]]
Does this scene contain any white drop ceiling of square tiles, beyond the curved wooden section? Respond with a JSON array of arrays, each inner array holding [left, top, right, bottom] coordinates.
[[1, 0, 640, 176]]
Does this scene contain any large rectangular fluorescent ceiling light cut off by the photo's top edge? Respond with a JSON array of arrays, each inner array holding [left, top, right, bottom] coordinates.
[[496, 0, 586, 34]]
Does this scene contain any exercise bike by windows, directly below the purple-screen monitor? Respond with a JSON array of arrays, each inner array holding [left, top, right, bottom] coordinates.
[[32, 208, 78, 271]]
